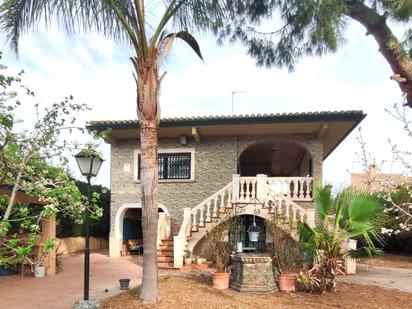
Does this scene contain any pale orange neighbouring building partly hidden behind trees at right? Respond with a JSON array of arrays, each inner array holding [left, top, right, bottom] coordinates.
[[351, 164, 412, 192]]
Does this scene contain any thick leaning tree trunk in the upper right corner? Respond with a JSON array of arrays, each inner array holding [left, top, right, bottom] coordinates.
[[346, 1, 412, 108]]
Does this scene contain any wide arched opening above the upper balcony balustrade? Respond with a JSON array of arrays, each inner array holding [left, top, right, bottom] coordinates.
[[239, 141, 313, 177]]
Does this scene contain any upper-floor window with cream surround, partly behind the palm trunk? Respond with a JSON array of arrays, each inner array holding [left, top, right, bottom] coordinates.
[[135, 149, 194, 181]]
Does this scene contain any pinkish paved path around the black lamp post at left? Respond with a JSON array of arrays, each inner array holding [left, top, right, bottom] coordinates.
[[0, 253, 142, 309]]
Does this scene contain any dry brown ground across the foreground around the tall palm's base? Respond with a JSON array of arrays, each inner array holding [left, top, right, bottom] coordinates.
[[101, 276, 411, 309]]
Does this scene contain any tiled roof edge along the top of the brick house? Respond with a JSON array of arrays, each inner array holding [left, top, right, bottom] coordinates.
[[87, 110, 365, 129]]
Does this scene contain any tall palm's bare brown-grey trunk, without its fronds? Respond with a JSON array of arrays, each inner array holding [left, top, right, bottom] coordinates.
[[134, 55, 160, 302]]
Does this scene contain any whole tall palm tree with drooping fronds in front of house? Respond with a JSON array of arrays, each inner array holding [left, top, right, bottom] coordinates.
[[0, 0, 222, 302]]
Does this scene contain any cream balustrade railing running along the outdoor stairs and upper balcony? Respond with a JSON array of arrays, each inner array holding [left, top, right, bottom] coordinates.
[[174, 174, 315, 268]]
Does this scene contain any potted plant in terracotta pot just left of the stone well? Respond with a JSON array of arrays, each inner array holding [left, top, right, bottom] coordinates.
[[206, 219, 232, 289]]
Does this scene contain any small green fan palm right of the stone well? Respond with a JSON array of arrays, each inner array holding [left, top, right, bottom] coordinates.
[[298, 186, 383, 292]]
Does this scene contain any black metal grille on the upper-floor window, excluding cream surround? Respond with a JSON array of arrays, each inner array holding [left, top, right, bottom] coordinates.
[[137, 153, 192, 179]]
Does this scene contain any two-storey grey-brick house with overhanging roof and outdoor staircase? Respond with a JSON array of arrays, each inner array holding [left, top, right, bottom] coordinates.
[[88, 111, 365, 267]]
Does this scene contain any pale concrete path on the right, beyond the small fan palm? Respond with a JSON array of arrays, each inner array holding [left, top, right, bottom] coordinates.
[[338, 264, 412, 293]]
